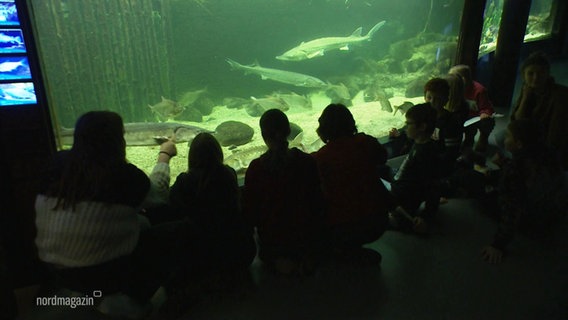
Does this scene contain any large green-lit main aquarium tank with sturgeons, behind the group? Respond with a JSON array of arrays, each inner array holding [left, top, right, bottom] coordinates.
[[28, 0, 463, 177]]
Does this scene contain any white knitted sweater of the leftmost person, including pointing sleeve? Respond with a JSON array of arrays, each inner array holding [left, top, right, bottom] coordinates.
[[35, 163, 170, 268]]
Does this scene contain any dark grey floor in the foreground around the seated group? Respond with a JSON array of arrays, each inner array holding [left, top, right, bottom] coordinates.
[[21, 199, 568, 320]]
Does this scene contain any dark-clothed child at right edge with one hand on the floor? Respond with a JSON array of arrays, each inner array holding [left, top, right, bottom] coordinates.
[[482, 119, 568, 263]]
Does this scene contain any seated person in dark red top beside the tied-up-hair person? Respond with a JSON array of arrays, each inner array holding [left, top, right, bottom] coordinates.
[[312, 104, 392, 262]]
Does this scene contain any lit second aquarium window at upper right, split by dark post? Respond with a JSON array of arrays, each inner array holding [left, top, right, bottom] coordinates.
[[479, 0, 555, 57]]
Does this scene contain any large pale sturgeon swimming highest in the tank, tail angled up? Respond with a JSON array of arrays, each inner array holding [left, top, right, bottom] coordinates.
[[276, 21, 385, 61]]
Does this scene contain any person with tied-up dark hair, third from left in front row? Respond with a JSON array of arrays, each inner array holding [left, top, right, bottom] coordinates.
[[243, 109, 325, 275]]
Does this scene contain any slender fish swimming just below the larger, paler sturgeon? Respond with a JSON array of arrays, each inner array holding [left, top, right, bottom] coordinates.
[[227, 58, 326, 88]]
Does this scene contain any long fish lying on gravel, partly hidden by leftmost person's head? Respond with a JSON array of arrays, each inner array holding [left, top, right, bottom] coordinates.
[[59, 122, 213, 146]]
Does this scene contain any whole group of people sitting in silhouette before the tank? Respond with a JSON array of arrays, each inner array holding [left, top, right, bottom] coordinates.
[[35, 52, 567, 318]]
